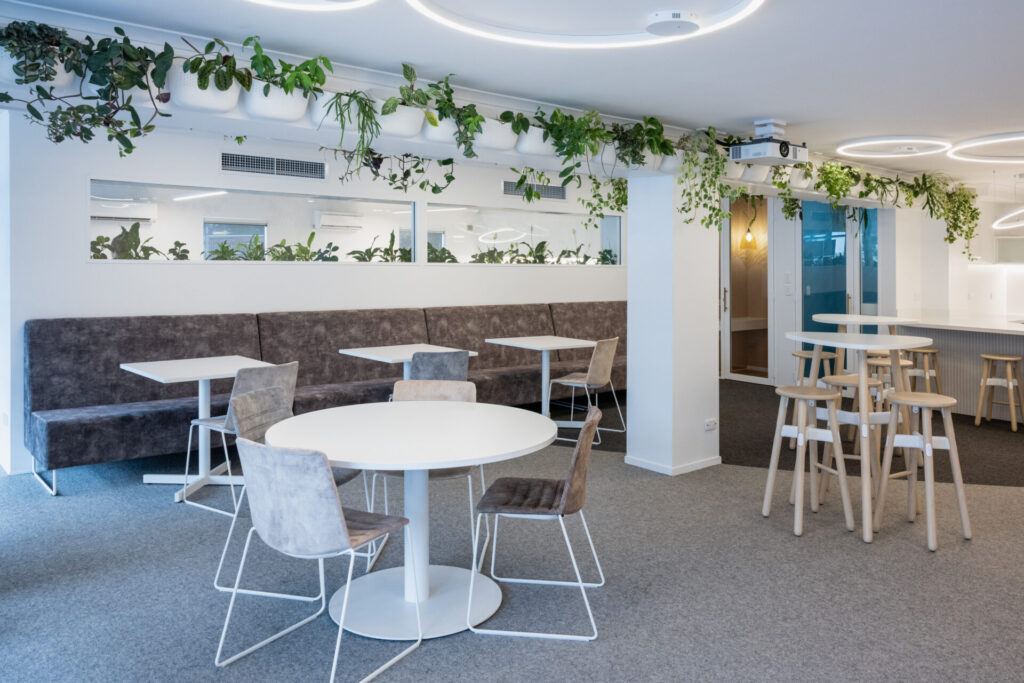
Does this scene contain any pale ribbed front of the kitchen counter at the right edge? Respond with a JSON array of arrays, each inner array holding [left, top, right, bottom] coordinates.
[[899, 326, 1024, 420]]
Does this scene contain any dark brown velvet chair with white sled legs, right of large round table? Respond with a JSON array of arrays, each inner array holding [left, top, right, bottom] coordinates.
[[466, 405, 604, 640]]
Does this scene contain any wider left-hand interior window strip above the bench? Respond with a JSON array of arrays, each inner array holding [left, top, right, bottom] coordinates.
[[89, 180, 415, 262]]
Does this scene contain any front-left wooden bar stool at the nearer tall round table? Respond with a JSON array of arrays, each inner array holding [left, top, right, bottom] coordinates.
[[761, 386, 853, 536]]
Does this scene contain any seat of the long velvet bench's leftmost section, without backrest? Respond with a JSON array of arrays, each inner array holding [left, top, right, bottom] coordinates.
[[28, 394, 228, 470]]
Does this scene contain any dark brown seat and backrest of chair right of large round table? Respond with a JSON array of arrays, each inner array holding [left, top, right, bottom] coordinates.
[[476, 408, 601, 515]]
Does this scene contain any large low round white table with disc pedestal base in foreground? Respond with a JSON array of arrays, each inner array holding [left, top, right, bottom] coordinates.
[[266, 401, 558, 640]]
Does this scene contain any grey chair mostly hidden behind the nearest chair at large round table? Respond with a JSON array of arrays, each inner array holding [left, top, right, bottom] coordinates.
[[213, 386, 371, 602]]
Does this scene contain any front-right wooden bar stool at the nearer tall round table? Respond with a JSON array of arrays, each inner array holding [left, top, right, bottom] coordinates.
[[873, 391, 971, 550]]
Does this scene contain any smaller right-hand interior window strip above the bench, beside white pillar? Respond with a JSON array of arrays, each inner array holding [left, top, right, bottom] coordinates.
[[424, 204, 622, 265]]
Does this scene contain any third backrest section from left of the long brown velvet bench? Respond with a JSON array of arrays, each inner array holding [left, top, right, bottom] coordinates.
[[424, 303, 555, 370]]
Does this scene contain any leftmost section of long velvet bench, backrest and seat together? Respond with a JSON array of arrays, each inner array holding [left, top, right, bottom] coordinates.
[[24, 314, 260, 469]]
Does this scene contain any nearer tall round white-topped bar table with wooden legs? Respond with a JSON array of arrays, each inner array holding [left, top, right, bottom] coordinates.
[[785, 332, 932, 543]]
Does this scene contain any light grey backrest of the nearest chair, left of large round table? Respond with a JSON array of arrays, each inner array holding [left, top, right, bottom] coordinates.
[[238, 437, 351, 557]]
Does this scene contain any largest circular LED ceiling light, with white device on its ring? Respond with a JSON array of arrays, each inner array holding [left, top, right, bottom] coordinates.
[[406, 0, 765, 50]]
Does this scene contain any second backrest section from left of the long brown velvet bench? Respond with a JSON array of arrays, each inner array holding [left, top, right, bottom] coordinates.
[[258, 308, 427, 386]]
